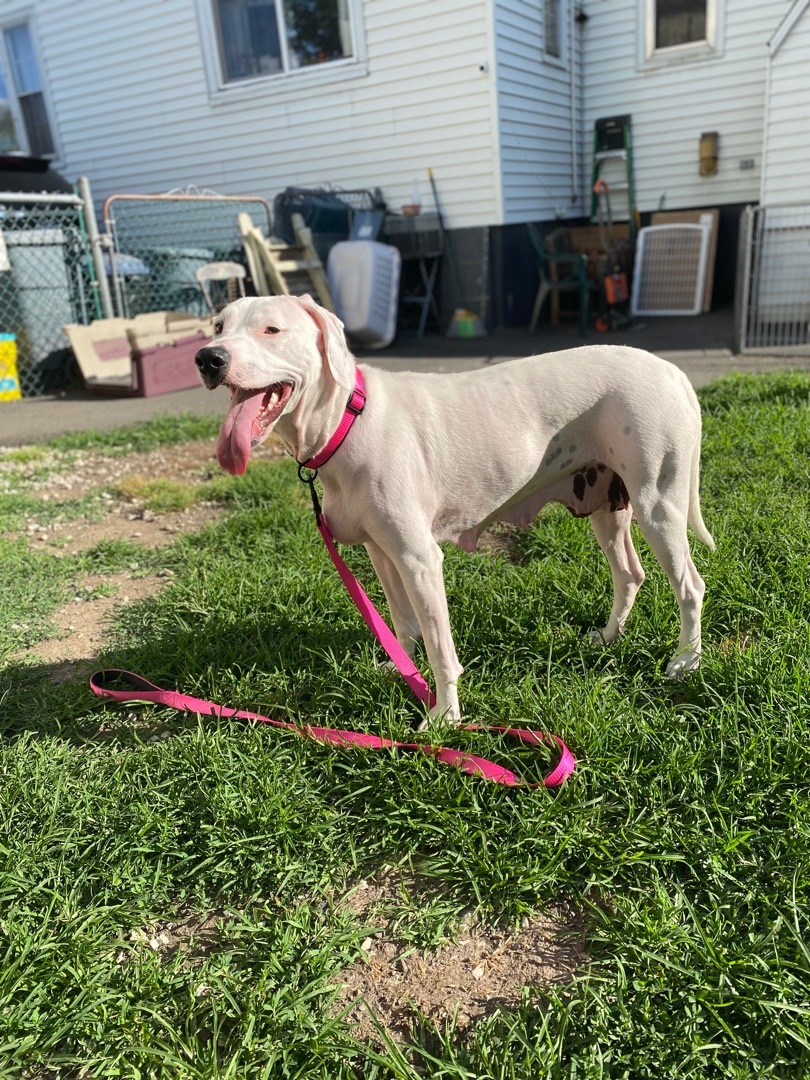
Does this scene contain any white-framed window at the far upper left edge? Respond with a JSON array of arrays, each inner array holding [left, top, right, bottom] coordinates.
[[0, 23, 56, 158]]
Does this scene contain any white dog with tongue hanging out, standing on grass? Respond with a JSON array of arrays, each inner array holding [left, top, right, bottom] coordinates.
[[197, 296, 714, 719]]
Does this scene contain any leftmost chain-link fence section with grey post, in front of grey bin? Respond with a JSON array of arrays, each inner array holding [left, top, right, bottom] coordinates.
[[0, 192, 102, 397]]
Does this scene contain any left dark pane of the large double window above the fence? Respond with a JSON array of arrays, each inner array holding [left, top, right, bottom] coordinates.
[[216, 0, 282, 82]]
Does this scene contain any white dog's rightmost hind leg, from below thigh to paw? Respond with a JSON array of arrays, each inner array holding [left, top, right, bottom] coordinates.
[[633, 487, 706, 678]]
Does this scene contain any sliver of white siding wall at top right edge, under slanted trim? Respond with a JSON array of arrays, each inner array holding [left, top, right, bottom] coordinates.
[[761, 9, 810, 203]]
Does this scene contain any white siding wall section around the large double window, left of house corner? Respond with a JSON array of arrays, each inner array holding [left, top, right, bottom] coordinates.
[[30, 0, 500, 227]]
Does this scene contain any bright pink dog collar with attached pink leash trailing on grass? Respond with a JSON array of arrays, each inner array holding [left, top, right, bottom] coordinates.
[[90, 369, 576, 787]]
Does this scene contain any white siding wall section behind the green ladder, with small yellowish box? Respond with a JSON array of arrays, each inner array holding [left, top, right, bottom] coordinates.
[[582, 0, 789, 211]]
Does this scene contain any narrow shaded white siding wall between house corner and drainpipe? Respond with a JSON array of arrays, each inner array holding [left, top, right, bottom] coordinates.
[[495, 0, 585, 224]]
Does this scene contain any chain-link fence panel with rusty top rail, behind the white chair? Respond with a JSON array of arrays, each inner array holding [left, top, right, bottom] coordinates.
[[103, 193, 272, 318]]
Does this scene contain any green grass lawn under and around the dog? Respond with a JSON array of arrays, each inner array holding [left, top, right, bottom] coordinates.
[[0, 374, 810, 1080]]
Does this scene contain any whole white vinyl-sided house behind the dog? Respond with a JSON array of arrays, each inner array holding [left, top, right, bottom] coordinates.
[[0, 0, 810, 322]]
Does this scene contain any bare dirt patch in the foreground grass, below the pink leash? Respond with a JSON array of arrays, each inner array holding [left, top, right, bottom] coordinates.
[[336, 872, 586, 1042]]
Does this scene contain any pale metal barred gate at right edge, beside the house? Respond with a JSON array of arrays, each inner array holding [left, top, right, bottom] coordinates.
[[734, 203, 810, 355]]
